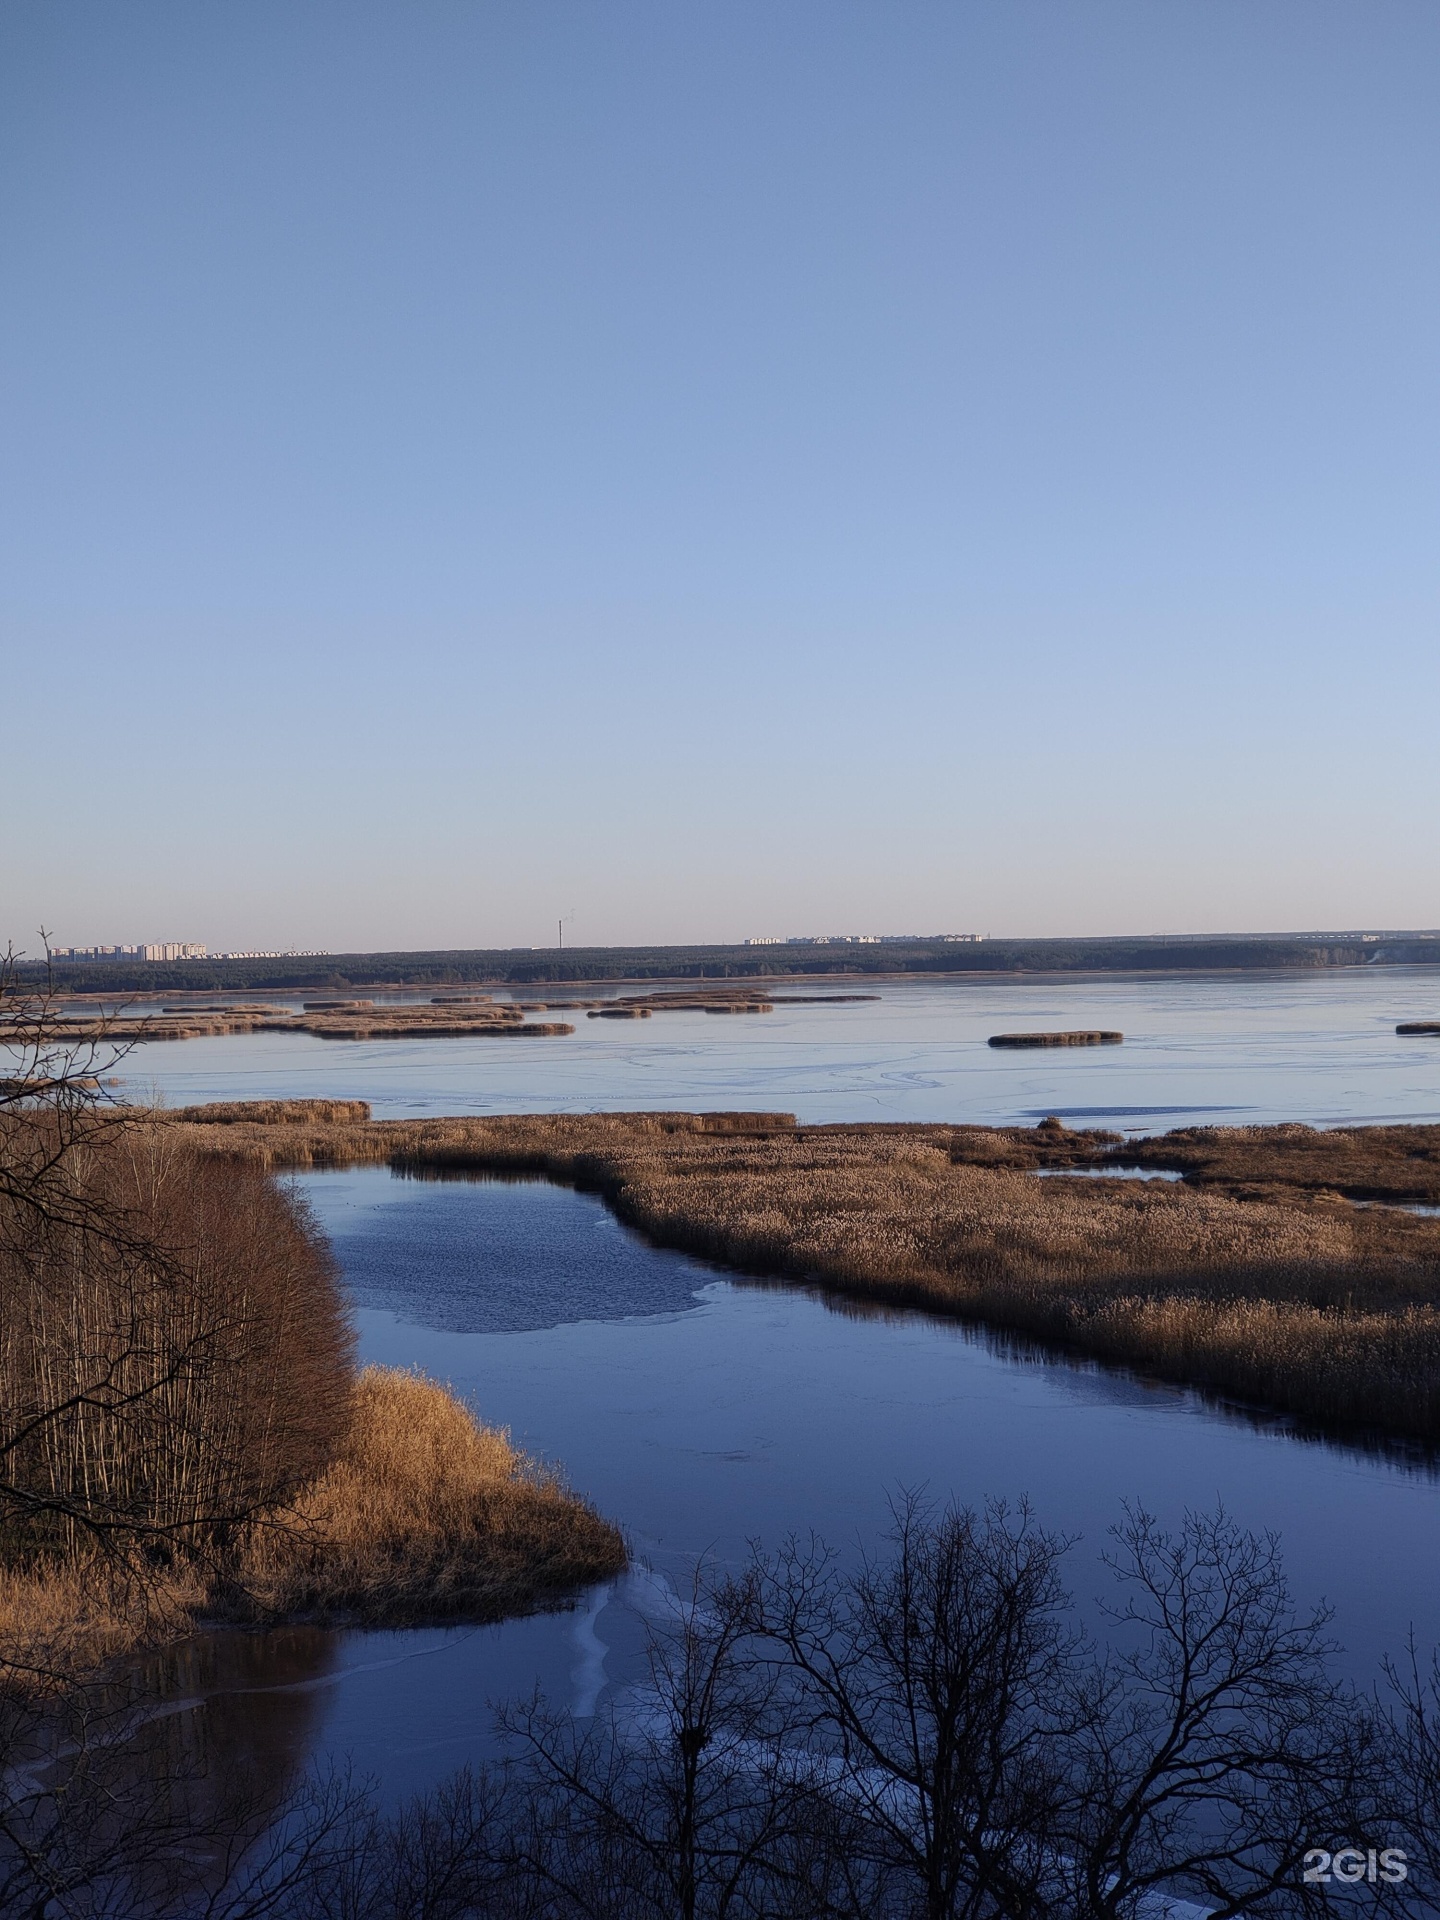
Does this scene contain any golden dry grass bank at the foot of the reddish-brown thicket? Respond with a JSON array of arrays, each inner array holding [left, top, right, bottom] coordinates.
[[0, 1367, 626, 1686]]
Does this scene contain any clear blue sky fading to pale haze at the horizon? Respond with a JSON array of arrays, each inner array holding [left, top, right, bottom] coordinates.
[[0, 0, 1440, 948]]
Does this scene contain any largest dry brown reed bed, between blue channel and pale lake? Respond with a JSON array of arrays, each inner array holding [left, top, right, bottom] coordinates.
[[175, 1102, 1440, 1442]]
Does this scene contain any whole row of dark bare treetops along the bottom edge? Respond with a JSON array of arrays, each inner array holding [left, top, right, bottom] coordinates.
[[90, 1501, 1413, 1920]]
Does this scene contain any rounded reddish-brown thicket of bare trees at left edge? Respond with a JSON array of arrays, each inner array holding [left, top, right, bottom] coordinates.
[[0, 936, 351, 1571]]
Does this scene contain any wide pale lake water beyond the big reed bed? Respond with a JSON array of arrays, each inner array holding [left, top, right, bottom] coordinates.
[[121, 968, 1440, 1133]]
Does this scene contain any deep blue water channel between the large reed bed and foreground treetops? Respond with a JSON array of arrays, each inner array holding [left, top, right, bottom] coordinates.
[[184, 1169, 1440, 1795]]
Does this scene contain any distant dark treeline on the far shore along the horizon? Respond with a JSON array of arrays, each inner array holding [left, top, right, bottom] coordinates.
[[21, 933, 1440, 993]]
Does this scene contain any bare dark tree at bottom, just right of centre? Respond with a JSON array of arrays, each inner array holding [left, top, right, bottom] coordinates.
[[755, 1496, 1083, 1920]]
